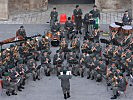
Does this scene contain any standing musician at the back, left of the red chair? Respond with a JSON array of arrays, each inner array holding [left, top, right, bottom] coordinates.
[[50, 8, 58, 26]]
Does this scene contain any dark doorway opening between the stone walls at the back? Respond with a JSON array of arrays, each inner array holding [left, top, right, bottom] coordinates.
[[49, 0, 95, 4]]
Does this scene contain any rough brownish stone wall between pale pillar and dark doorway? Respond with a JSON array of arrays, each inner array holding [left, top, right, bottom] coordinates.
[[8, 0, 48, 14]]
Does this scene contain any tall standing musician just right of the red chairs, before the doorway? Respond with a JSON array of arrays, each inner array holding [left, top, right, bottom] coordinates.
[[73, 5, 83, 34]]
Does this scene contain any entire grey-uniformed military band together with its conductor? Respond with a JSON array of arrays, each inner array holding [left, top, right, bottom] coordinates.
[[0, 5, 133, 99]]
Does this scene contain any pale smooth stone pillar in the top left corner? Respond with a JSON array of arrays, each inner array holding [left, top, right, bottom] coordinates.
[[0, 0, 8, 20]]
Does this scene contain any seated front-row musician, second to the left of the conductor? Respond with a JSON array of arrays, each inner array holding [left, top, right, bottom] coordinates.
[[41, 50, 52, 76]]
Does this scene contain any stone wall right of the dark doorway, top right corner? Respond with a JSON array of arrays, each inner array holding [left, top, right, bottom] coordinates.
[[95, 0, 132, 11]]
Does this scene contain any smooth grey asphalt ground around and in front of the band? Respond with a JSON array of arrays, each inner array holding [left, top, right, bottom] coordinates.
[[0, 25, 133, 100]]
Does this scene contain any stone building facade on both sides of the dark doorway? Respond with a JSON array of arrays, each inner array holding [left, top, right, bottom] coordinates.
[[0, 0, 133, 20]]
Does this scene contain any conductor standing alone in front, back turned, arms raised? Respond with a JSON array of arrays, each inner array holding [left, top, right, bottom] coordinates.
[[58, 70, 72, 99]]
